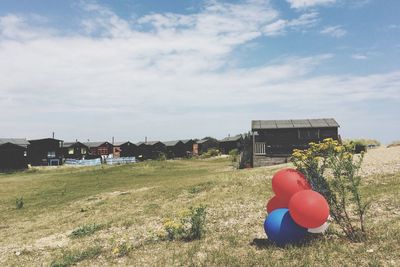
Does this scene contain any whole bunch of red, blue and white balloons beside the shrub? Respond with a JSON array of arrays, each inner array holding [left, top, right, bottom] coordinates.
[[264, 169, 329, 246]]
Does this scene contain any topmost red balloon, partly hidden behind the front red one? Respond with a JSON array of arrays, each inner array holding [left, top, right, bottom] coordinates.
[[272, 169, 311, 202]]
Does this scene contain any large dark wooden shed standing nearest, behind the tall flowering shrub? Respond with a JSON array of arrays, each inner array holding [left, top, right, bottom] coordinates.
[[251, 118, 340, 167]]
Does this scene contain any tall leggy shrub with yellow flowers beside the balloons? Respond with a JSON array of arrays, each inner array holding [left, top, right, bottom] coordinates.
[[291, 138, 369, 241]]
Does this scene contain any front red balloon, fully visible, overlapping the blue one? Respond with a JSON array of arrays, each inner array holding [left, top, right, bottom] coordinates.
[[289, 190, 329, 228]]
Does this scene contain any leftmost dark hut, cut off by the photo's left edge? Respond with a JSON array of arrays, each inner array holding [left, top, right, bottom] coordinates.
[[0, 138, 29, 171]]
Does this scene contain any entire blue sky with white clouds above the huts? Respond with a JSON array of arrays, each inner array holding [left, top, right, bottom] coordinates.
[[0, 0, 400, 143]]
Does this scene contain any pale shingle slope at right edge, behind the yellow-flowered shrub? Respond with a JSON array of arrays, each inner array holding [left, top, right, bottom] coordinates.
[[361, 146, 400, 176]]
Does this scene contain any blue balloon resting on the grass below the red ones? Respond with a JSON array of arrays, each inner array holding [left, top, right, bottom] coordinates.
[[264, 209, 307, 246]]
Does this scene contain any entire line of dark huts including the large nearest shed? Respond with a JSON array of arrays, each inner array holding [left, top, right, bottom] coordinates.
[[0, 118, 341, 170]]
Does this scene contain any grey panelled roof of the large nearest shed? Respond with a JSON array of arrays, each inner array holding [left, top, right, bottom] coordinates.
[[251, 118, 340, 130]]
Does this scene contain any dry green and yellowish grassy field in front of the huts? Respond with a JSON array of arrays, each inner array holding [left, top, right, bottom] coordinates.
[[0, 158, 400, 266]]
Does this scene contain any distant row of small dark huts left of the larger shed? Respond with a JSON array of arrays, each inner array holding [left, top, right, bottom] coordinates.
[[0, 135, 243, 170]]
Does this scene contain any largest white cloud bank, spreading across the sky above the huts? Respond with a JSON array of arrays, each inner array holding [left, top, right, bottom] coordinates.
[[0, 1, 400, 141]]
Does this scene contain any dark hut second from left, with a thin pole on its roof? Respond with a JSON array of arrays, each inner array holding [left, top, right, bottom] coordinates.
[[28, 138, 63, 166]]
